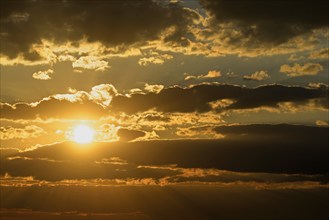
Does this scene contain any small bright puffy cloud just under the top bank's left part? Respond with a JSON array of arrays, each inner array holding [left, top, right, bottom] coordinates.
[[72, 56, 110, 72]]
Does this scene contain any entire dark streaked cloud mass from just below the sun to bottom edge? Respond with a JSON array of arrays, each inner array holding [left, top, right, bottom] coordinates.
[[0, 125, 329, 219]]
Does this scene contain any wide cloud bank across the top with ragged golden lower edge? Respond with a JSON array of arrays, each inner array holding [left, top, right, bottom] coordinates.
[[0, 0, 326, 65]]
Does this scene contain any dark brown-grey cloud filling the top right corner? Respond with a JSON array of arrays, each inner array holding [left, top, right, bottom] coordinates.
[[200, 0, 329, 45]]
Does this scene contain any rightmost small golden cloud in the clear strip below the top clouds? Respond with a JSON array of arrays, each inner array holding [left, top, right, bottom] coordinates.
[[280, 63, 323, 77]]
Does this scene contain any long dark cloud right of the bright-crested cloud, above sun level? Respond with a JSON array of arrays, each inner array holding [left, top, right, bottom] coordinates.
[[112, 84, 328, 113]]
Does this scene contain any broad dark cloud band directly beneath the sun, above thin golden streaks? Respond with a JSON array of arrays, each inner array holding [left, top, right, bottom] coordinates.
[[1, 124, 329, 179]]
